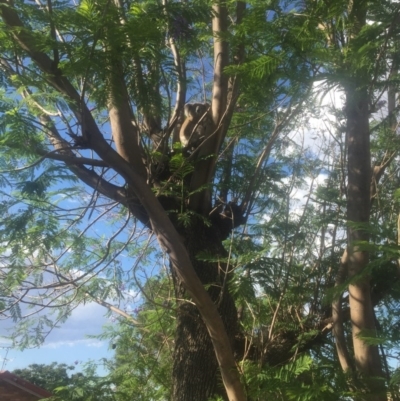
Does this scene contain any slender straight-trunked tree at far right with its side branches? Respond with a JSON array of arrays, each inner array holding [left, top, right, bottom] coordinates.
[[310, 1, 398, 400]]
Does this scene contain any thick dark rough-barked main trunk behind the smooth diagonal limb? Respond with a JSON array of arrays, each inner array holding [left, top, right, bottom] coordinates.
[[172, 221, 238, 401]]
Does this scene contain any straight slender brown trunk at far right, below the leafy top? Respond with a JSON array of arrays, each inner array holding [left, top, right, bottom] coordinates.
[[346, 85, 386, 401]]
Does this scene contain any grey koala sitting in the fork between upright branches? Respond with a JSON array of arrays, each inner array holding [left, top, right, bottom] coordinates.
[[179, 103, 211, 148]]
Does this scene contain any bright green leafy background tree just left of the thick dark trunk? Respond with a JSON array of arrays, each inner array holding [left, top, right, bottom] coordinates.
[[100, 277, 176, 401]]
